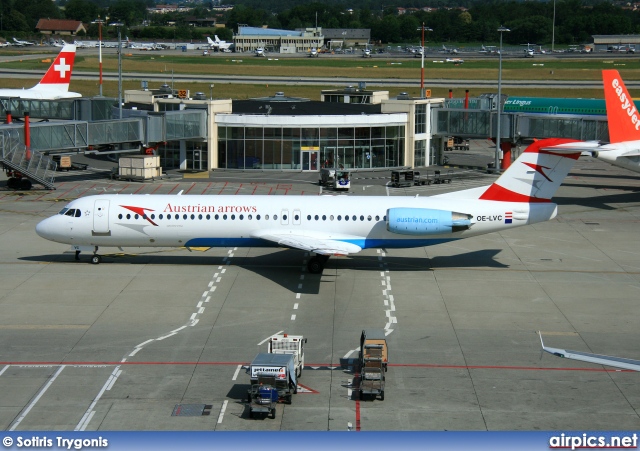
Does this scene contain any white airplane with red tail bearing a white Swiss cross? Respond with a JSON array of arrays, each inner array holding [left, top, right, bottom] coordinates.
[[0, 44, 82, 100]]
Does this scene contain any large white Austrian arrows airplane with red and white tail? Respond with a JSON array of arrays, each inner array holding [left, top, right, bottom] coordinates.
[[36, 138, 581, 273]]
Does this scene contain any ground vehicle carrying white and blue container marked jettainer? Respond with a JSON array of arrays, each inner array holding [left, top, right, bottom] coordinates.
[[247, 352, 298, 404]]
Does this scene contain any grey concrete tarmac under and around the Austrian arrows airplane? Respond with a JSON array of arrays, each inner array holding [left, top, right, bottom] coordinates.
[[0, 142, 640, 431]]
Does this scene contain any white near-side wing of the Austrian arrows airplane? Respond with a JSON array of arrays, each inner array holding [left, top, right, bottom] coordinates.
[[253, 230, 362, 255]]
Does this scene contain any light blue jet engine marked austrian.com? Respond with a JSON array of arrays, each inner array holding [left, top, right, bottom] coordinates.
[[387, 208, 472, 235]]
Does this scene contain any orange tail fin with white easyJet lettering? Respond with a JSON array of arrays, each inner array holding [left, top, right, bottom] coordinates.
[[602, 70, 640, 143]]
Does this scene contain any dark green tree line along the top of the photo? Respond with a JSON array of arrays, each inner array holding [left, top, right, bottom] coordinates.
[[0, 0, 640, 45]]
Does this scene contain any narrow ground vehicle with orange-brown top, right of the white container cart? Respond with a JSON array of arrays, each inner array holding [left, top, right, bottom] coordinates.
[[358, 329, 389, 401]]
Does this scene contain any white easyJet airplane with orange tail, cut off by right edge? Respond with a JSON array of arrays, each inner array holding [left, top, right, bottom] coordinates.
[[583, 69, 640, 172]]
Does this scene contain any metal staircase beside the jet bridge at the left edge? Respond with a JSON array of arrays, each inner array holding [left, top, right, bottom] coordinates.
[[0, 129, 57, 190]]
